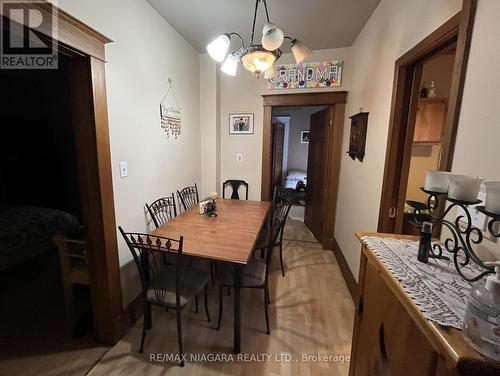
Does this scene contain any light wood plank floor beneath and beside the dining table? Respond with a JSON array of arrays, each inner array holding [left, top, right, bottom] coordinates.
[[89, 221, 354, 376]]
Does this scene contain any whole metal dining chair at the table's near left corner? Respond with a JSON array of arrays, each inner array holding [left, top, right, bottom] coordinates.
[[118, 226, 210, 367]]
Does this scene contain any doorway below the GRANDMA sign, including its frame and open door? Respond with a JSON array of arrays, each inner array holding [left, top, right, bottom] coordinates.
[[262, 92, 346, 249]]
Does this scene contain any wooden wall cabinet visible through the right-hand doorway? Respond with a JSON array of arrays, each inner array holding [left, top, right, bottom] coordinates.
[[413, 98, 448, 144]]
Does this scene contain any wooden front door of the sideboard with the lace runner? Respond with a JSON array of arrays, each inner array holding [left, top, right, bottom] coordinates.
[[350, 261, 438, 376]]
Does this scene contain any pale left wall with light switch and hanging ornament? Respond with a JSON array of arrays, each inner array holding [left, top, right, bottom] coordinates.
[[58, 0, 201, 305]]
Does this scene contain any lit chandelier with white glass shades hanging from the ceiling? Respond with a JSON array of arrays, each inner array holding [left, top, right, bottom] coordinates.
[[207, 0, 311, 79]]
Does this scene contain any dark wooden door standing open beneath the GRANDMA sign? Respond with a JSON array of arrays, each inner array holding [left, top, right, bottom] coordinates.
[[304, 108, 330, 242]]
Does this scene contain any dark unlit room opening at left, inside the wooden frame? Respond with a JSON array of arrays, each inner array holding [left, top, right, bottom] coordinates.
[[0, 54, 105, 373]]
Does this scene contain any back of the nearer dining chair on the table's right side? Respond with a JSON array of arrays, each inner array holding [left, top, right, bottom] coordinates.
[[266, 187, 294, 266]]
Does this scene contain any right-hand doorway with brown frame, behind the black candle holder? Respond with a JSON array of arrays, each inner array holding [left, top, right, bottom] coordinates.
[[378, 0, 477, 235]]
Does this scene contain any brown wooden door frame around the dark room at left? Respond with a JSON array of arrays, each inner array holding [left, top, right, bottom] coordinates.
[[0, 2, 124, 345]]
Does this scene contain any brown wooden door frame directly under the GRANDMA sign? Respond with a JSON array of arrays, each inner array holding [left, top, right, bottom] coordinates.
[[261, 91, 347, 249]]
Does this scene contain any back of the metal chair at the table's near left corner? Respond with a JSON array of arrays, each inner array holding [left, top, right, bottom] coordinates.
[[118, 226, 184, 306]]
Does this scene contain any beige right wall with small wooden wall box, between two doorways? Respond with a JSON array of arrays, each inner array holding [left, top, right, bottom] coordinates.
[[335, 0, 462, 276]]
